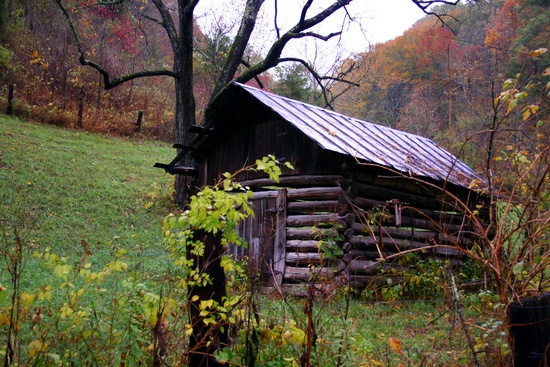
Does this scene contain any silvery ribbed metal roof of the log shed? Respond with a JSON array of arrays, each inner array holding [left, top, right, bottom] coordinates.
[[227, 83, 485, 187]]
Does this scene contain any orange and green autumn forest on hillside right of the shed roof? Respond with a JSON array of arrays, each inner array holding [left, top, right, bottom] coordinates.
[[335, 0, 550, 168]]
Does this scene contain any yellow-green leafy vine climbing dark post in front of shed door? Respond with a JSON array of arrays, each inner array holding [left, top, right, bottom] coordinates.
[[164, 155, 292, 363]]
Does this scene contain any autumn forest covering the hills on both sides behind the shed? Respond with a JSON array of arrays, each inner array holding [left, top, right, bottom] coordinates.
[[0, 0, 550, 165]]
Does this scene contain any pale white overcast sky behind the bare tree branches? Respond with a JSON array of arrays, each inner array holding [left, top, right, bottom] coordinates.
[[195, 0, 432, 75]]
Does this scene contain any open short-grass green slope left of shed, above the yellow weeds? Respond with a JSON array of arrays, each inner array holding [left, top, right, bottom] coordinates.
[[0, 115, 174, 278]]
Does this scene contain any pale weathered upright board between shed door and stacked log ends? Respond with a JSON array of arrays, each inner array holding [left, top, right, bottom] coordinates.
[[273, 189, 287, 287]]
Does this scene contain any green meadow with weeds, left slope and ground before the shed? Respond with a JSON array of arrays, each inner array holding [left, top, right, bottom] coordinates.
[[0, 115, 509, 366]]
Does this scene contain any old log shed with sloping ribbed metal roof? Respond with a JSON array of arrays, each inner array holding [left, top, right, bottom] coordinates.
[[162, 83, 487, 294]]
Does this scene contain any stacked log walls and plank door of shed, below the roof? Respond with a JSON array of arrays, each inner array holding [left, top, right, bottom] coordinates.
[[232, 175, 485, 294]]
